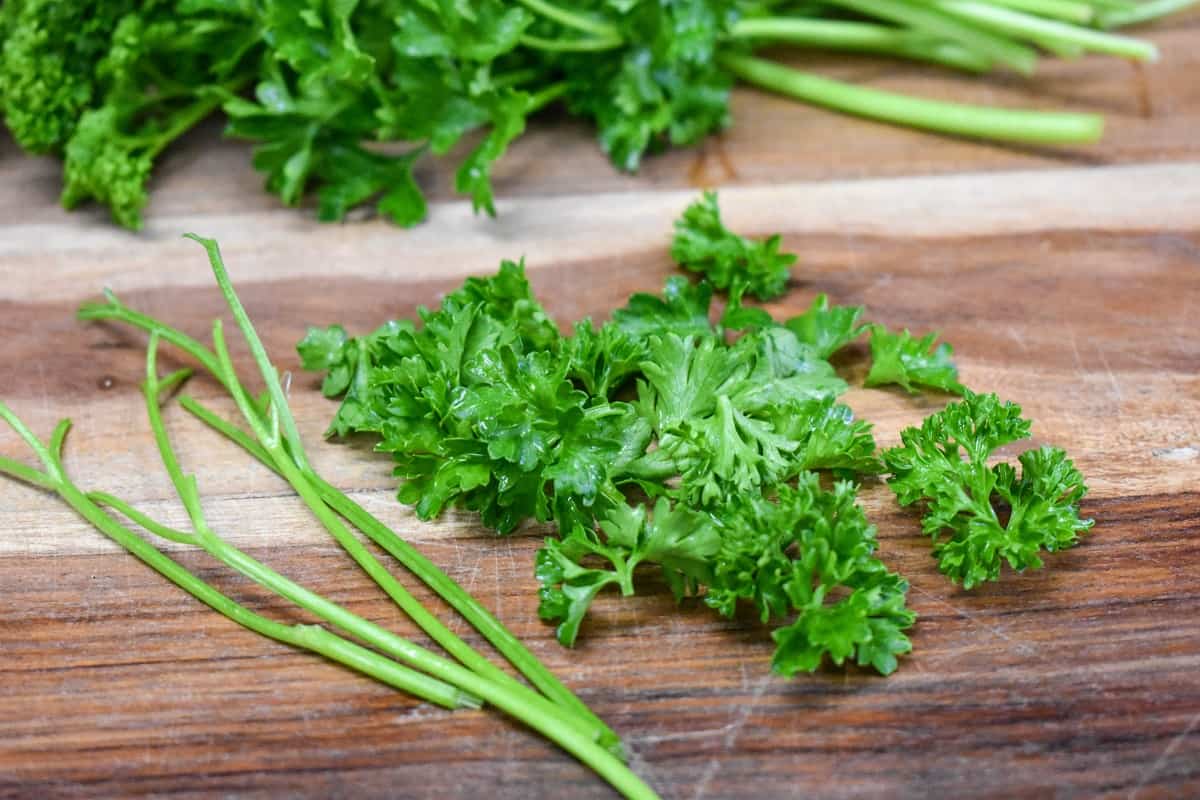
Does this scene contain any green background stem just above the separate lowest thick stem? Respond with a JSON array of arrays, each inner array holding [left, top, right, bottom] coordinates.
[[730, 17, 991, 72]]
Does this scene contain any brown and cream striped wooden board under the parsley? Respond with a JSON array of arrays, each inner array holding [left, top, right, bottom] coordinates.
[[0, 14, 1200, 800]]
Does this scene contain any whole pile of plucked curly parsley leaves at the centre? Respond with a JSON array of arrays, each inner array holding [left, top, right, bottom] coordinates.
[[299, 194, 1091, 675]]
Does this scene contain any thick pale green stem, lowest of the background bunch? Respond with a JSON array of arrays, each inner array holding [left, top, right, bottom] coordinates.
[[720, 54, 1104, 144]]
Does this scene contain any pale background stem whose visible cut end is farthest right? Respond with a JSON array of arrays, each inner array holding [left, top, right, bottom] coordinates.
[[934, 0, 1158, 61]]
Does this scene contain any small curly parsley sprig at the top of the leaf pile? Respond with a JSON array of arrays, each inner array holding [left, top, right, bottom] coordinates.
[[671, 192, 796, 300]]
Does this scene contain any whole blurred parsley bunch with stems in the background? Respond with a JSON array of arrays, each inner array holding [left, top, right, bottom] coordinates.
[[0, 0, 1193, 228]]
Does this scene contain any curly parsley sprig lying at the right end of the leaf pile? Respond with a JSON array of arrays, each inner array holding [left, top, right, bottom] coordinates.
[[883, 391, 1092, 589]]
